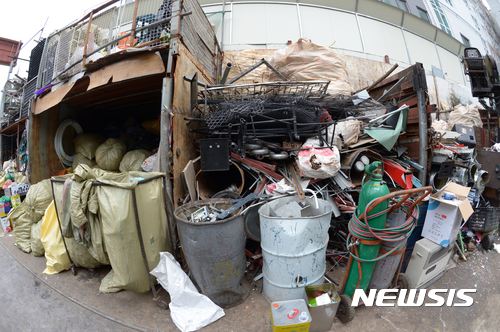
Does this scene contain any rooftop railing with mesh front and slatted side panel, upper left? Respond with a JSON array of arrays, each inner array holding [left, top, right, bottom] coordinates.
[[37, 0, 220, 88]]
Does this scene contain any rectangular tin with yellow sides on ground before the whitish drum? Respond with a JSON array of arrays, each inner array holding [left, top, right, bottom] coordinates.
[[271, 300, 311, 332]]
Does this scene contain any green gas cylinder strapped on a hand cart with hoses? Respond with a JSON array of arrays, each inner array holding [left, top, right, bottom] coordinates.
[[344, 161, 389, 298]]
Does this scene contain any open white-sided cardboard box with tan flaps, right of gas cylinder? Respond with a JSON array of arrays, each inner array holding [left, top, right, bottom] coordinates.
[[422, 182, 474, 247]]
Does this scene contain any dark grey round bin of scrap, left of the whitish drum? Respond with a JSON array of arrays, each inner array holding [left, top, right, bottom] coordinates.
[[175, 198, 248, 308]]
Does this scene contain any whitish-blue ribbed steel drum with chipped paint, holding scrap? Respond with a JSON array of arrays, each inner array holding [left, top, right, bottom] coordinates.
[[259, 196, 332, 302]]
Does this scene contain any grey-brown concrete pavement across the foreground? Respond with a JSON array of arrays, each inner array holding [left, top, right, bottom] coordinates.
[[0, 231, 500, 332]]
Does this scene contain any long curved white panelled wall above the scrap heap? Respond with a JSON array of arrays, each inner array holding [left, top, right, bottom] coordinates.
[[200, 0, 473, 84]]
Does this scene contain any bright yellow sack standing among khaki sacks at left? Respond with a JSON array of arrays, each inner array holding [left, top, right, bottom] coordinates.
[[40, 202, 70, 274]]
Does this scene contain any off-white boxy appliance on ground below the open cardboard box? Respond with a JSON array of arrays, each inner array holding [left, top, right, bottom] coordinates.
[[405, 238, 455, 289]]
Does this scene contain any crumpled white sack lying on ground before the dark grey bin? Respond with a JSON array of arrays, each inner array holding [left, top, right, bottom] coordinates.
[[151, 252, 224, 332]]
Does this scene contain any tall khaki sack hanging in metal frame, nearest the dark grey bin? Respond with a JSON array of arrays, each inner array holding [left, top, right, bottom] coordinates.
[[97, 172, 171, 293]]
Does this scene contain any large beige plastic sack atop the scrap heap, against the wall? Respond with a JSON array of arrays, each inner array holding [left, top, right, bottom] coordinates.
[[269, 38, 352, 96]]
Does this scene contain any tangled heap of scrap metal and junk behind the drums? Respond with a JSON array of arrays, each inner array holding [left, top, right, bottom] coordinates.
[[179, 67, 422, 265]]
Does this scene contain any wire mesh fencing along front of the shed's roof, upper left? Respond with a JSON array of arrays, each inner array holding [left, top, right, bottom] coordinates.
[[40, 0, 172, 87]]
